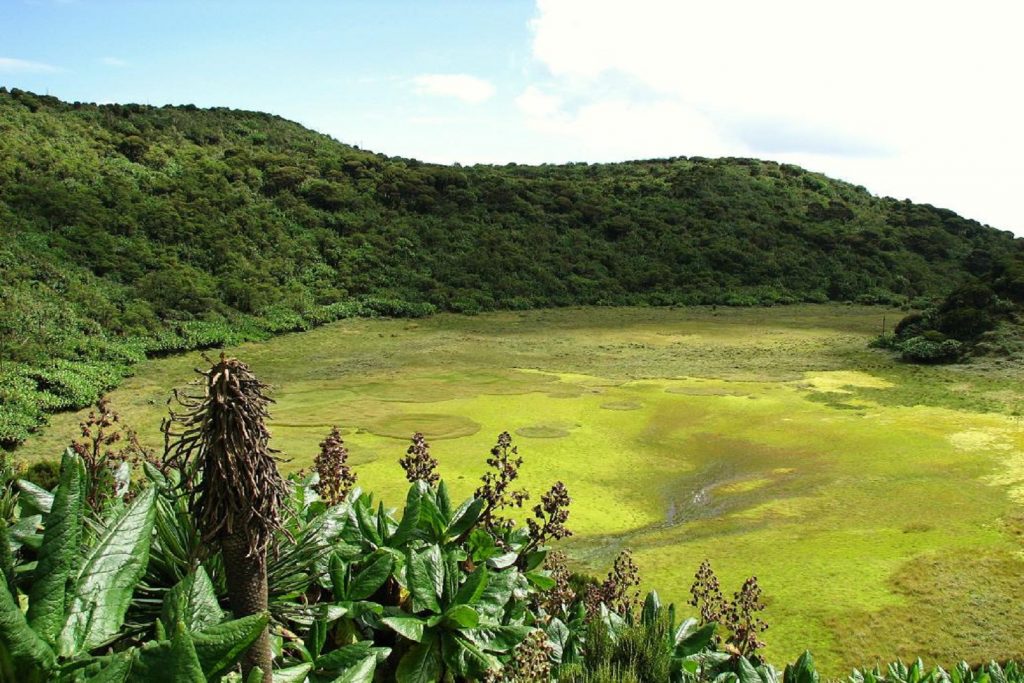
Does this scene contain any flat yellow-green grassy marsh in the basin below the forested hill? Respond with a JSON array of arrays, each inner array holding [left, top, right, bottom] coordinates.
[[18, 306, 1024, 675]]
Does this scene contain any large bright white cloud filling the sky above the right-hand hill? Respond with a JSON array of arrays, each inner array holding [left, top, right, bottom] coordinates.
[[517, 0, 1024, 234]]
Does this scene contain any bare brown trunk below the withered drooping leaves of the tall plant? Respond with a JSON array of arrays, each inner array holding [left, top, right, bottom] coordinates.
[[220, 533, 273, 683]]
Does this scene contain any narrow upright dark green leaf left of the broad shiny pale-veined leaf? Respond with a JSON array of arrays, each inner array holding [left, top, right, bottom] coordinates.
[[27, 449, 84, 654]]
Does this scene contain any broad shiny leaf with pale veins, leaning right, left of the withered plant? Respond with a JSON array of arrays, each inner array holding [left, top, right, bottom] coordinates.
[[54, 486, 157, 656]]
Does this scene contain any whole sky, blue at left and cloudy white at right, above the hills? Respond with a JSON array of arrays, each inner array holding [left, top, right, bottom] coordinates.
[[0, 0, 1024, 236]]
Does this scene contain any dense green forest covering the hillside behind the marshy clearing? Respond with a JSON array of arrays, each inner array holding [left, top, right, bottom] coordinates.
[[0, 89, 1021, 447]]
